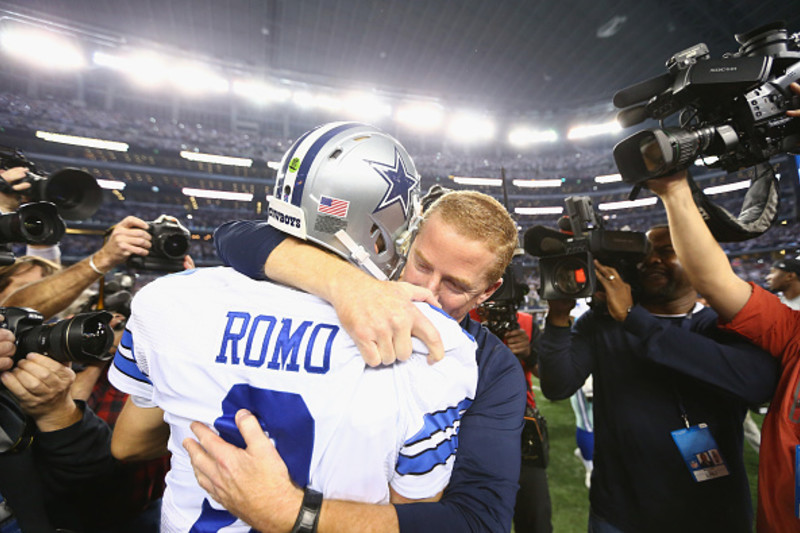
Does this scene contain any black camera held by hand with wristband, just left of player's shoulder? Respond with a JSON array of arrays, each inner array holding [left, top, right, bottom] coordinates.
[[128, 215, 191, 272]]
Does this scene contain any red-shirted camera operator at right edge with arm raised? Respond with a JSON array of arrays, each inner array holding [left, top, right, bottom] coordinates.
[[646, 83, 800, 532]]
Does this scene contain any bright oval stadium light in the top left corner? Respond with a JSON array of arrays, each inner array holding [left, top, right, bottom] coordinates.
[[0, 27, 86, 71]]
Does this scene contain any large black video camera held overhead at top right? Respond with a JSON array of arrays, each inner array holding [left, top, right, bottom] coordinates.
[[614, 22, 800, 183]]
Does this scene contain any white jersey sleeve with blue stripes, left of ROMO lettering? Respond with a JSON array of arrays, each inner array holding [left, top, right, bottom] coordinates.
[[108, 292, 156, 407]]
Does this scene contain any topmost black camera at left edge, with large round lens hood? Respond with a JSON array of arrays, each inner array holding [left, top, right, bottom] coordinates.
[[0, 146, 103, 220]]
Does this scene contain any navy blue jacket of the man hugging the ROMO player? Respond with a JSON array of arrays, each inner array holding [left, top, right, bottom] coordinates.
[[214, 221, 526, 533]]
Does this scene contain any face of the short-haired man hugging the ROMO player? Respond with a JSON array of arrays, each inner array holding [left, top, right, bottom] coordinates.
[[400, 215, 502, 321]]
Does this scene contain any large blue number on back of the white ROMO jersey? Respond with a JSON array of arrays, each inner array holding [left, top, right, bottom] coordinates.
[[190, 384, 314, 533]]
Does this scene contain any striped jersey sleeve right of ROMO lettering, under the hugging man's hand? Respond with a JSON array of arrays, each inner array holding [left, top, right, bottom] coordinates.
[[390, 308, 478, 499]]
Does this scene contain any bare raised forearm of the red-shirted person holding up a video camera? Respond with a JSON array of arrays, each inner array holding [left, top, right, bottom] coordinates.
[[647, 171, 752, 322]]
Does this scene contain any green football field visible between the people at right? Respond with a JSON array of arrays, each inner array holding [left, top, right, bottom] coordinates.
[[512, 383, 763, 533]]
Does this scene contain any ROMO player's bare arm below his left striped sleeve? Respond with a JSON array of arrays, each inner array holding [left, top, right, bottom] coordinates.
[[111, 397, 169, 461]]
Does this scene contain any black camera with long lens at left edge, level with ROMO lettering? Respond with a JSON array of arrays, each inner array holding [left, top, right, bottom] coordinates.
[[0, 307, 114, 363]]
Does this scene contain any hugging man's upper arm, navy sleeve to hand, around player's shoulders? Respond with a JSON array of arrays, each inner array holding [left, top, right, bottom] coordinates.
[[214, 221, 443, 366]]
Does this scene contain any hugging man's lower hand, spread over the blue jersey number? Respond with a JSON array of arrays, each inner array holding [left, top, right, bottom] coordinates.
[[183, 409, 303, 532]]
